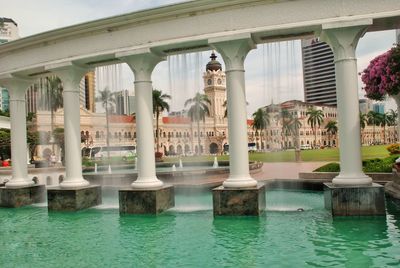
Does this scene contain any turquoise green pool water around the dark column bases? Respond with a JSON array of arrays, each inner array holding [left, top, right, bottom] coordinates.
[[0, 191, 400, 267]]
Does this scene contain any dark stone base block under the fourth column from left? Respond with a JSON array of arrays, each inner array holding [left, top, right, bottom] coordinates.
[[213, 183, 266, 216]]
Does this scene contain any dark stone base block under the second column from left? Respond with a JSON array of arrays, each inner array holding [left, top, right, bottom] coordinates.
[[47, 185, 102, 211]]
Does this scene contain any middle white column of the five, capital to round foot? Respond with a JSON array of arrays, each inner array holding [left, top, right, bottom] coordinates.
[[117, 50, 164, 188]]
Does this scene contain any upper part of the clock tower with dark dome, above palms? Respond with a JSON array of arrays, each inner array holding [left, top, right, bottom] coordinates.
[[203, 52, 226, 121]]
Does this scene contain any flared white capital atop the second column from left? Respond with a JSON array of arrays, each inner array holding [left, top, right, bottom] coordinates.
[[45, 62, 90, 91]]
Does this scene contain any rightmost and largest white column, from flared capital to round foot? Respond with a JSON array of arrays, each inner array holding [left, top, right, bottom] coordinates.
[[321, 20, 372, 185]]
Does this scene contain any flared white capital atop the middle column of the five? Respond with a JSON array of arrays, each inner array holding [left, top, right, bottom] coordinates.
[[115, 48, 166, 82]]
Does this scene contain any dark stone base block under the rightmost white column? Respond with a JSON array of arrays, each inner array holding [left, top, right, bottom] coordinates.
[[324, 183, 386, 216]]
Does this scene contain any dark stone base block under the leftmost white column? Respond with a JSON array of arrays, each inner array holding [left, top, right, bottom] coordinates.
[[0, 185, 46, 208]]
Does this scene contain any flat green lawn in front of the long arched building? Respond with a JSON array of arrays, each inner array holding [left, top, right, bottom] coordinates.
[[164, 145, 389, 162]]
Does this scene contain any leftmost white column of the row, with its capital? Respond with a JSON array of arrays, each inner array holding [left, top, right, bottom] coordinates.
[[2, 77, 34, 188]]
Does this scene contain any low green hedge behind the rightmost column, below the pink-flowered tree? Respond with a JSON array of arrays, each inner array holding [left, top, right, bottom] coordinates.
[[314, 155, 399, 173]]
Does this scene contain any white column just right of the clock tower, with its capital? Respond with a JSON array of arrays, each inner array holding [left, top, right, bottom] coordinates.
[[209, 36, 257, 188]]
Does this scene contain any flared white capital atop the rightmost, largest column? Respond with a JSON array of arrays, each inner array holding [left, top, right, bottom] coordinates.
[[318, 19, 372, 62]]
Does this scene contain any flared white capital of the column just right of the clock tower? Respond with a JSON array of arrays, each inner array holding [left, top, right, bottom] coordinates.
[[208, 34, 256, 72]]
